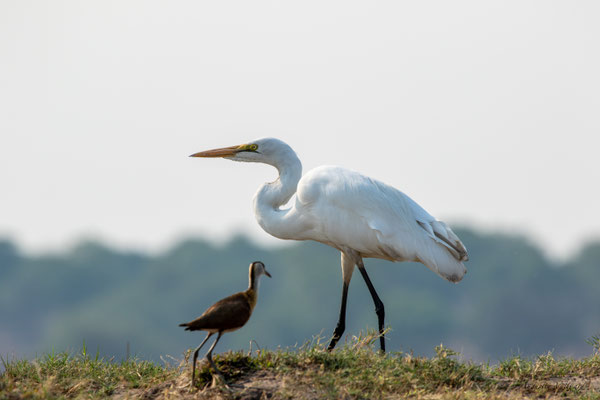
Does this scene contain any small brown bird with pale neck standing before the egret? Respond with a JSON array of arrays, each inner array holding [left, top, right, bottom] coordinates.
[[179, 261, 271, 387]]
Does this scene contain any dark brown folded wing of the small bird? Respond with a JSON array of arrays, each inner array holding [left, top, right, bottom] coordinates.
[[180, 292, 252, 332]]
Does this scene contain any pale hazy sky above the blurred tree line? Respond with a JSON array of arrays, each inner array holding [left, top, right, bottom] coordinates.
[[0, 0, 600, 256]]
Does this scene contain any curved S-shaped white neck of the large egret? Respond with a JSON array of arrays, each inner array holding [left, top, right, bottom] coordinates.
[[254, 151, 302, 239]]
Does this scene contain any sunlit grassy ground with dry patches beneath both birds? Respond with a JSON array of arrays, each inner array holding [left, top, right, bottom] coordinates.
[[0, 335, 600, 400]]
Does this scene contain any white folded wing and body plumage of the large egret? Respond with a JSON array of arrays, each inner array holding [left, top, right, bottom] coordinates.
[[296, 166, 466, 281]]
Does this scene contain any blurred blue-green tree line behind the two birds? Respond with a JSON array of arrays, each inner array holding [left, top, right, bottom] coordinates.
[[0, 228, 600, 362]]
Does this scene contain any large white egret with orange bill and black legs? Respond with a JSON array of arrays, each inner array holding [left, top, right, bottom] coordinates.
[[191, 138, 468, 351]]
